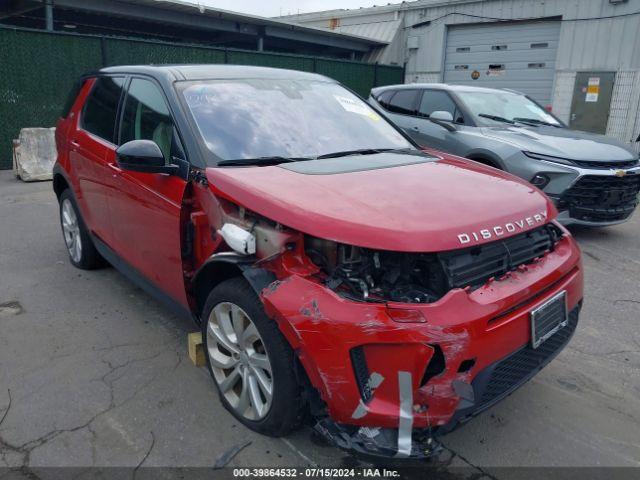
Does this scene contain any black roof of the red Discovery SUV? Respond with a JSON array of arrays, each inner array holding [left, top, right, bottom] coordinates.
[[99, 64, 335, 82]]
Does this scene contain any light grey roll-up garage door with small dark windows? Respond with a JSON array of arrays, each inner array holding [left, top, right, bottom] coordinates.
[[444, 21, 560, 106]]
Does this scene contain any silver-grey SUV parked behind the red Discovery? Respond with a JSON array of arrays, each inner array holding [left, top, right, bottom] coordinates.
[[369, 84, 640, 226]]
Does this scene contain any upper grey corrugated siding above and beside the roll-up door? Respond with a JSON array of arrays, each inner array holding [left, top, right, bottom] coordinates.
[[404, 0, 640, 80]]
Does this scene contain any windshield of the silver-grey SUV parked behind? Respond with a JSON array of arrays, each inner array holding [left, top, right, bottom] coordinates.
[[457, 91, 560, 126]]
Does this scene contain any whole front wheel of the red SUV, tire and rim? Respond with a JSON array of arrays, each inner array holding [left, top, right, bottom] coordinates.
[[202, 277, 305, 437]]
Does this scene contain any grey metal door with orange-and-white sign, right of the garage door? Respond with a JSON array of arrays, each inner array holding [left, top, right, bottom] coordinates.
[[569, 72, 616, 135]]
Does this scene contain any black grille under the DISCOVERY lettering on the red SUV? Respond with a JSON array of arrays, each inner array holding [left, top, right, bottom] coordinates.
[[439, 224, 562, 288]]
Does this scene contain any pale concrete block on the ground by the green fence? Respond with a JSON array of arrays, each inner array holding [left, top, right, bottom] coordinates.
[[13, 128, 57, 182]]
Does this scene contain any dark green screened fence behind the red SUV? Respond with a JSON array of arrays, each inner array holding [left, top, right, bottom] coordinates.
[[0, 27, 404, 169]]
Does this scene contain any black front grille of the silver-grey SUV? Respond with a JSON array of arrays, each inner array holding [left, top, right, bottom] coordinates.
[[559, 174, 640, 222]]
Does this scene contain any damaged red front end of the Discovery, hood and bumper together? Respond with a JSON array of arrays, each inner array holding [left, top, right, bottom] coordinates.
[[196, 156, 583, 456]]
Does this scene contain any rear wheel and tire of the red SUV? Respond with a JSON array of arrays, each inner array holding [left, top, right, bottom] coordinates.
[[59, 189, 105, 270]]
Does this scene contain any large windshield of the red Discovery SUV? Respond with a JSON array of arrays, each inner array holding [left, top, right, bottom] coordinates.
[[181, 79, 414, 164]]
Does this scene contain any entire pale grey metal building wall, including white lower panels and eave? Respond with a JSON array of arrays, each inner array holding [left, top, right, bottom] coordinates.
[[288, 0, 640, 149]]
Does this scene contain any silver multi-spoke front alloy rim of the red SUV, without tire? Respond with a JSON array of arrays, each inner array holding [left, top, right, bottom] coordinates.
[[207, 302, 273, 421]]
